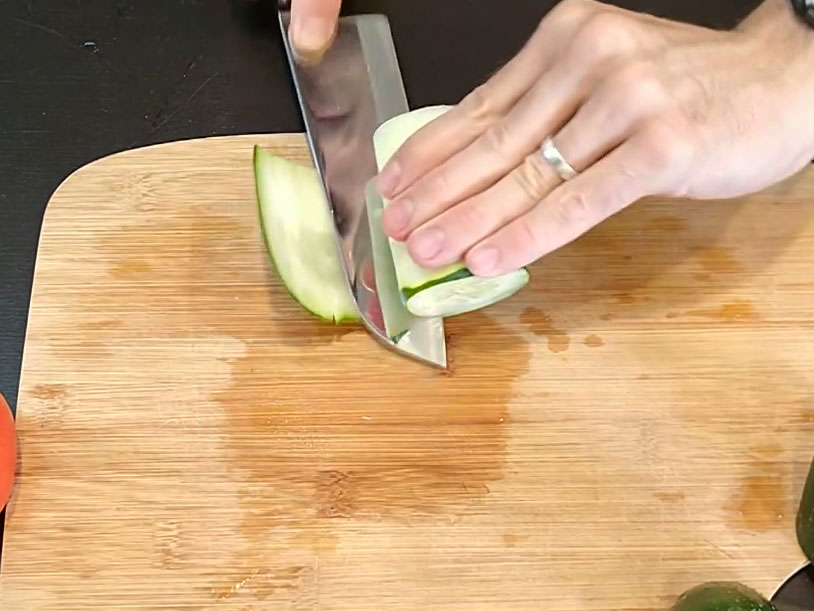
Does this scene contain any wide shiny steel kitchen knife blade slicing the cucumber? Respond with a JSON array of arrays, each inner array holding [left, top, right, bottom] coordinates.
[[278, 2, 447, 369]]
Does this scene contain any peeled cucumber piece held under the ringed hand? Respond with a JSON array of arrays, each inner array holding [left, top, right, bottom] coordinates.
[[373, 106, 529, 317]]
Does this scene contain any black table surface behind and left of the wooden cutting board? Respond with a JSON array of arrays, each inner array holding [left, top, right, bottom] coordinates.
[[9, 0, 811, 596]]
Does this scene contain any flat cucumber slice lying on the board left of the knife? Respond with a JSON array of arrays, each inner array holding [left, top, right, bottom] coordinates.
[[254, 146, 361, 324]]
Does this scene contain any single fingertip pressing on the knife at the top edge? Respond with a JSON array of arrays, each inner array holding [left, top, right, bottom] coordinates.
[[289, 0, 342, 60]]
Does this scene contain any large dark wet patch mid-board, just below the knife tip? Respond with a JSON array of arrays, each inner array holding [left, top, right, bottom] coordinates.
[[214, 314, 530, 533]]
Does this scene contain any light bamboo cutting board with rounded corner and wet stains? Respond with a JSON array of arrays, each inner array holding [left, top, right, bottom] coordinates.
[[0, 134, 814, 611]]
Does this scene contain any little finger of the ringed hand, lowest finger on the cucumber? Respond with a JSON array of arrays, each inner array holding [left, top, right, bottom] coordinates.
[[465, 135, 659, 276]]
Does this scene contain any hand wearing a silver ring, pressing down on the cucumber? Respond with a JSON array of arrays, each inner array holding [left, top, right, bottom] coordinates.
[[379, 0, 814, 276]]
